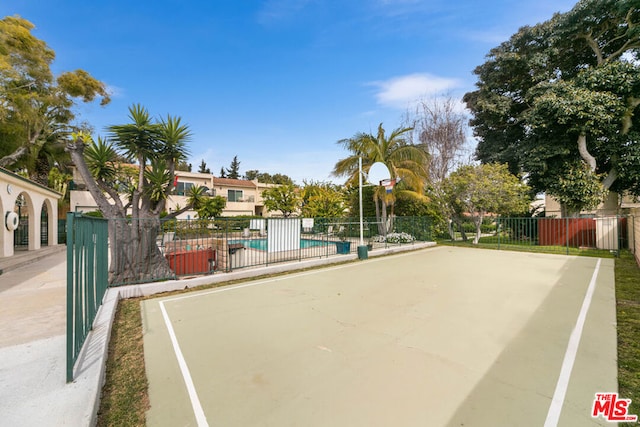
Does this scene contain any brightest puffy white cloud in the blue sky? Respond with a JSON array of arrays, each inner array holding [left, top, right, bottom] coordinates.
[[371, 73, 460, 109]]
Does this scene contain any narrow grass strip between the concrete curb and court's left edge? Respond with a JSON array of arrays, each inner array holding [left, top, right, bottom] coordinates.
[[97, 298, 149, 427]]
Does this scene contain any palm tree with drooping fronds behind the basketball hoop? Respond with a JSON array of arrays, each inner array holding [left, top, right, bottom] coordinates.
[[333, 123, 428, 232]]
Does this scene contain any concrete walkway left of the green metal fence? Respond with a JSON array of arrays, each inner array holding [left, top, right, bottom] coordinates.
[[0, 245, 95, 426]]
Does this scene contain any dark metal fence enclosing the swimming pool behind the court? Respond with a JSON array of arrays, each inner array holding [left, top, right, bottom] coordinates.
[[148, 217, 431, 276]]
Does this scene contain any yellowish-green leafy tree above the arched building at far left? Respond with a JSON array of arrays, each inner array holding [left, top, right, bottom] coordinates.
[[0, 16, 110, 184]]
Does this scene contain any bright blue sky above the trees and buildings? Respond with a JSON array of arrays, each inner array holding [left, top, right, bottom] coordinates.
[[0, 0, 576, 184]]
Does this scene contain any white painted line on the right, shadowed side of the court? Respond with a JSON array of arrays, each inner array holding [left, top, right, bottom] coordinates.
[[544, 258, 602, 427]]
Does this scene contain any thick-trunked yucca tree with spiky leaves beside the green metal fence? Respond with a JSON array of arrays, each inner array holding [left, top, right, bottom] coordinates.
[[67, 105, 195, 283]]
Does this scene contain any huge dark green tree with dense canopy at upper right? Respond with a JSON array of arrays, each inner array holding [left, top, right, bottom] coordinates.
[[464, 0, 640, 211]]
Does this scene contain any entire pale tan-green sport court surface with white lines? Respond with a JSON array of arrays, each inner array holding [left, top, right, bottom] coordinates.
[[142, 247, 617, 427]]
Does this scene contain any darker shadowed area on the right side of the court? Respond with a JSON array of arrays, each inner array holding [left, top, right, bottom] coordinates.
[[447, 258, 618, 427]]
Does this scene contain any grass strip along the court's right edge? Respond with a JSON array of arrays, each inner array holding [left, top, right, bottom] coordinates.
[[615, 251, 640, 425]]
